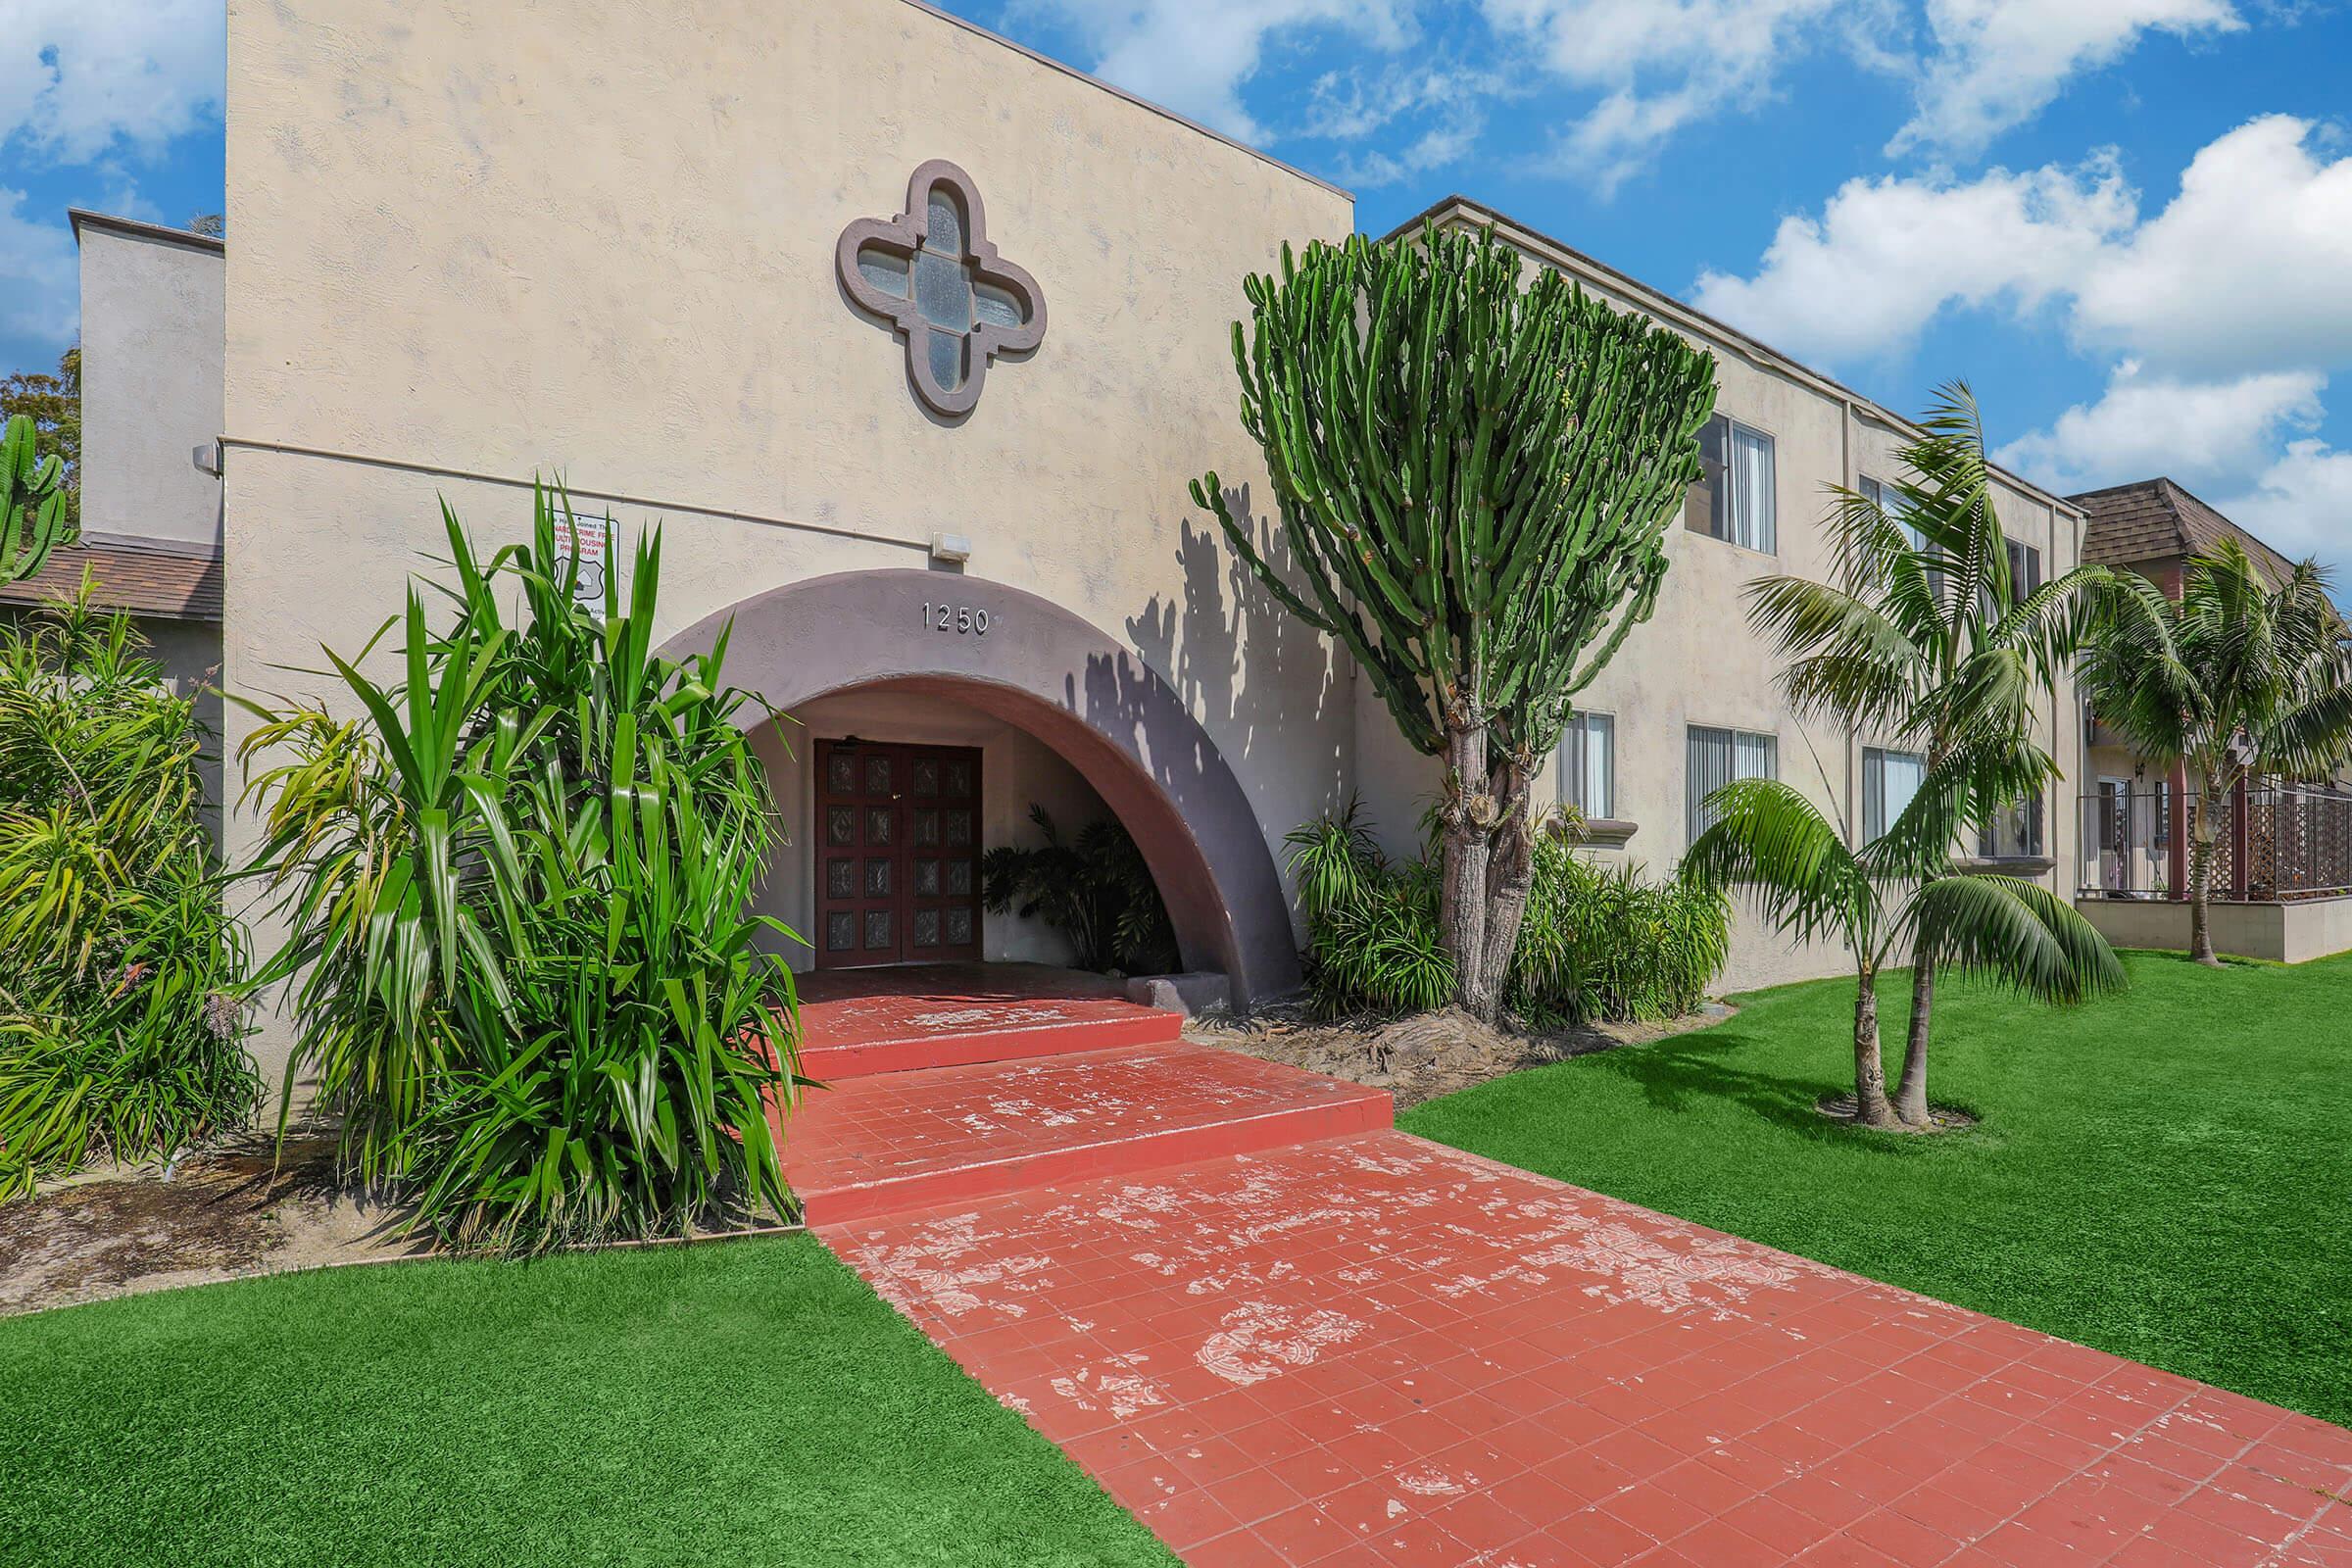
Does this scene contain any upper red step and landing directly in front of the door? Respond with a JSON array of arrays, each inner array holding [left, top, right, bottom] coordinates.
[[800, 964, 1183, 1084]]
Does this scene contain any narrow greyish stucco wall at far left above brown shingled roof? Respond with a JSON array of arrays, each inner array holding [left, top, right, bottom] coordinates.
[[75, 219, 228, 555]]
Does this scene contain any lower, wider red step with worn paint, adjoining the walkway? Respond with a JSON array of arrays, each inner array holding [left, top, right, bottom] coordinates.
[[783, 1042, 1393, 1225]]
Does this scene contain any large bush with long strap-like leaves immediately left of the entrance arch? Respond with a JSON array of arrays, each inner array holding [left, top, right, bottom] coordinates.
[[240, 489, 800, 1250]]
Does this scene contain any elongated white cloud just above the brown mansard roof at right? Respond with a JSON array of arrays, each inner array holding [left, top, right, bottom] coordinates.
[[1994, 360, 2328, 491]]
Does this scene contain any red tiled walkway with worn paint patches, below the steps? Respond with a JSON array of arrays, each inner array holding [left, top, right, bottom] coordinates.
[[821, 1131, 2352, 1568]]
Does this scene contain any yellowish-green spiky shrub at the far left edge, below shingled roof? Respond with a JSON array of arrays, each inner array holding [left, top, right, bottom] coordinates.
[[0, 573, 259, 1199]]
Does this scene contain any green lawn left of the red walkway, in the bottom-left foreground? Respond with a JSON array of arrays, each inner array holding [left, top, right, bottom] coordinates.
[[0, 1237, 1174, 1568]]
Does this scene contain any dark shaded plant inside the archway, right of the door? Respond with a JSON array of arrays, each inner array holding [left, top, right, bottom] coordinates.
[[981, 802, 1176, 976]]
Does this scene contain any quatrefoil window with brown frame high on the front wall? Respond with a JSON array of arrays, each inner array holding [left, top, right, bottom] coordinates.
[[835, 158, 1045, 418]]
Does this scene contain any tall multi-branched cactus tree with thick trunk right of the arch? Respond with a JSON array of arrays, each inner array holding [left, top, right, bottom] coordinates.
[[1193, 225, 1715, 1020]]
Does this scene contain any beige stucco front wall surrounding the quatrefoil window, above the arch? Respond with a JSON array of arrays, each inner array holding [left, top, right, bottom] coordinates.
[[225, 0, 1352, 1086]]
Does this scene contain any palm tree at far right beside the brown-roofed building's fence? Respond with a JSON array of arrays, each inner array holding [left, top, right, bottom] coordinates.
[[2083, 538, 2352, 964]]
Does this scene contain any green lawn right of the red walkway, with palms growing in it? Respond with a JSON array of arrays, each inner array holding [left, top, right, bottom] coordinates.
[[1399, 953, 2352, 1425]]
